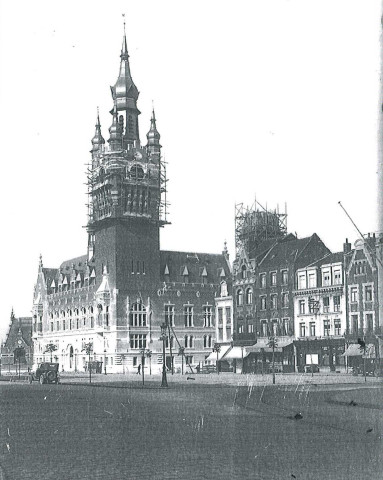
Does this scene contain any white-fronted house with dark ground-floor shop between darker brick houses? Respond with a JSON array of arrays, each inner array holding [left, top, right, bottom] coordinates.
[[294, 252, 347, 371]]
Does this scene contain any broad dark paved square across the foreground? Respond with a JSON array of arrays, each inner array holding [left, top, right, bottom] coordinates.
[[0, 375, 383, 480]]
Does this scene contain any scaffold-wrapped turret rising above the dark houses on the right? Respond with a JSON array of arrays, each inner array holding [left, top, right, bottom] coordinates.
[[235, 201, 287, 258]]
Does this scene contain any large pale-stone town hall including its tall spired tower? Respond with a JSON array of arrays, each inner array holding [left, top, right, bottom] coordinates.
[[33, 29, 231, 373]]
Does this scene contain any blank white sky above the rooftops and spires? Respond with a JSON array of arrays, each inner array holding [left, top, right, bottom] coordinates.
[[0, 0, 381, 338]]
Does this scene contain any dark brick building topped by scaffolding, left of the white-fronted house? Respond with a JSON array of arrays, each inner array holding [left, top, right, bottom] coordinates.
[[231, 201, 330, 373]]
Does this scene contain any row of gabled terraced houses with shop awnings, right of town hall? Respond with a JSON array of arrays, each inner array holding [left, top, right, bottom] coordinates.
[[214, 224, 383, 373]]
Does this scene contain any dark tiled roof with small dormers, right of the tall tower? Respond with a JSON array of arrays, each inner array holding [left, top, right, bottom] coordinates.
[[160, 250, 230, 283]]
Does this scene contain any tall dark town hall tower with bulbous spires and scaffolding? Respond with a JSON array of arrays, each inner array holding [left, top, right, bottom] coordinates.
[[87, 33, 167, 308]]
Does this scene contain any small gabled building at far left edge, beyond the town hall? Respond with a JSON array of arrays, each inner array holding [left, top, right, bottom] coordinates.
[[1, 309, 33, 373]]
